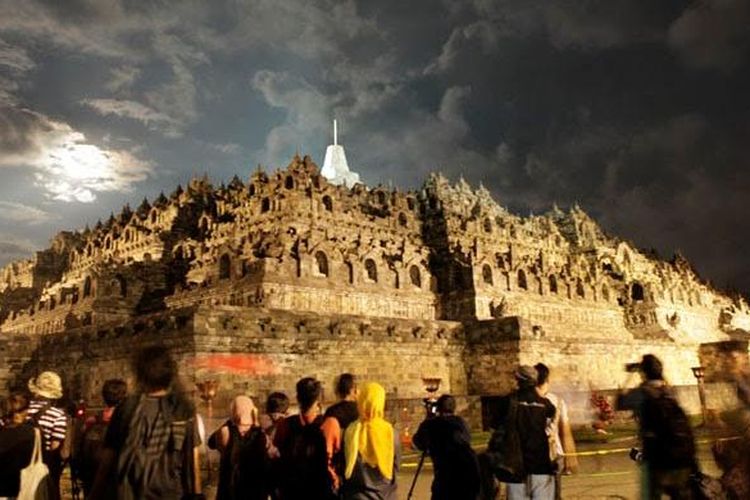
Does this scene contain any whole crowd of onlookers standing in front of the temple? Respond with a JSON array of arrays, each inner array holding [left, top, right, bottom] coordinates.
[[0, 346, 750, 500]]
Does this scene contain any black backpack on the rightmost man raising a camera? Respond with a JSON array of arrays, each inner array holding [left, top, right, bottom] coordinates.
[[640, 387, 696, 470]]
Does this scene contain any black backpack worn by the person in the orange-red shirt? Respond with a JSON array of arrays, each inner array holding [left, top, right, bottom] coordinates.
[[279, 415, 331, 498]]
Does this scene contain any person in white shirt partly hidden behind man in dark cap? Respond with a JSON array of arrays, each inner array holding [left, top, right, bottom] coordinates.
[[534, 363, 578, 500]]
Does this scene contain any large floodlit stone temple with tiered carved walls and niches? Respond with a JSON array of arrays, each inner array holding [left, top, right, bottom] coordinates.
[[0, 131, 750, 424]]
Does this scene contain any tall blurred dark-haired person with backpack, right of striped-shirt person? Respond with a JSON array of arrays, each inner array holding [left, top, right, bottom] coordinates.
[[91, 346, 203, 500]]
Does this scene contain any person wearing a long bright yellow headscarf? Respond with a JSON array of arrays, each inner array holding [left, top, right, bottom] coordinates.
[[341, 382, 399, 500]]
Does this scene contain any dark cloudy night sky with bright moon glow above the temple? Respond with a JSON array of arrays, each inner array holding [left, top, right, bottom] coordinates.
[[0, 0, 750, 293]]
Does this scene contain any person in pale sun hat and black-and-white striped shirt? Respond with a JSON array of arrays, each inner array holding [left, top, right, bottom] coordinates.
[[28, 371, 68, 499]]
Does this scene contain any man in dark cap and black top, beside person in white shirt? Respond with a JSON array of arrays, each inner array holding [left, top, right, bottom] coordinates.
[[481, 365, 556, 500]]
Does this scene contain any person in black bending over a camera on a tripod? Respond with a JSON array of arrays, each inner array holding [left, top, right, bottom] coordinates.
[[412, 394, 479, 500]]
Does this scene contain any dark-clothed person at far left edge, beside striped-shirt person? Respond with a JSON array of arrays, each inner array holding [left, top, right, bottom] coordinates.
[[0, 393, 38, 498]]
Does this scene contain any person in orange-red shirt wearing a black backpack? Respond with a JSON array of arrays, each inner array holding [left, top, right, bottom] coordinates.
[[273, 377, 333, 500]]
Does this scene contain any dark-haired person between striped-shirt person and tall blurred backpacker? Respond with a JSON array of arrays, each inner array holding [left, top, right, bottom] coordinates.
[[71, 378, 128, 497]]
